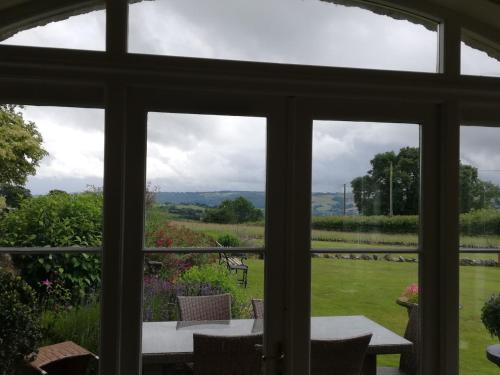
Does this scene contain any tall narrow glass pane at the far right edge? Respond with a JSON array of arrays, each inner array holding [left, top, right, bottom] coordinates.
[[460, 126, 500, 375]]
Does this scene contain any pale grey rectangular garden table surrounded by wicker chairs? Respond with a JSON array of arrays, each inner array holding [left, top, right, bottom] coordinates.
[[142, 316, 413, 375]]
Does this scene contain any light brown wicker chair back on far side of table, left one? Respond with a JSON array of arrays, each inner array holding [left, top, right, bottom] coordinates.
[[177, 294, 231, 320]]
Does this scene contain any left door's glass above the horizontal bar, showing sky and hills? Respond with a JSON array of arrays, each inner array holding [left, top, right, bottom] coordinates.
[[145, 113, 266, 248]]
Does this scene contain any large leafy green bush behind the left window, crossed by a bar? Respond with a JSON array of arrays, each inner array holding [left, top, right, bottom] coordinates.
[[0, 192, 102, 303]]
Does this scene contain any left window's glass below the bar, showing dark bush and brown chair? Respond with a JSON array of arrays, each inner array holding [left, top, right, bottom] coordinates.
[[0, 252, 101, 375]]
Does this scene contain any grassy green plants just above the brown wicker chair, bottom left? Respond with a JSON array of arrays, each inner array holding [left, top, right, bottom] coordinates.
[[41, 302, 100, 353]]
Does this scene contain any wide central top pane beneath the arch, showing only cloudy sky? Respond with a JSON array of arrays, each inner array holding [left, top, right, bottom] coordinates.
[[129, 0, 437, 73]]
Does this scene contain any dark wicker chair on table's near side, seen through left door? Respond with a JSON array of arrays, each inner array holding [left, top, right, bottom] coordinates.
[[193, 333, 262, 375]]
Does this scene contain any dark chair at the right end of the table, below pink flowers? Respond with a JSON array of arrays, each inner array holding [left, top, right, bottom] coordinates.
[[377, 305, 420, 375]]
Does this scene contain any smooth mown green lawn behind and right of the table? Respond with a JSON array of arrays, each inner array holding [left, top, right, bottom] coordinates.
[[240, 258, 500, 375]]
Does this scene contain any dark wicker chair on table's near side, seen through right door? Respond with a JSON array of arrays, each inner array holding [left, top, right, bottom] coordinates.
[[311, 334, 372, 375]]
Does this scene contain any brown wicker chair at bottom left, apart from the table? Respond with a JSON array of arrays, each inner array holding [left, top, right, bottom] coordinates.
[[21, 341, 99, 375]]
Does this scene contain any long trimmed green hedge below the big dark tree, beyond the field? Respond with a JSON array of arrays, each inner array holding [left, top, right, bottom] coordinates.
[[312, 209, 500, 236]]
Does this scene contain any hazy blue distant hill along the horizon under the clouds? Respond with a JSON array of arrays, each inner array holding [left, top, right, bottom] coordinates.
[[156, 191, 358, 216]]
